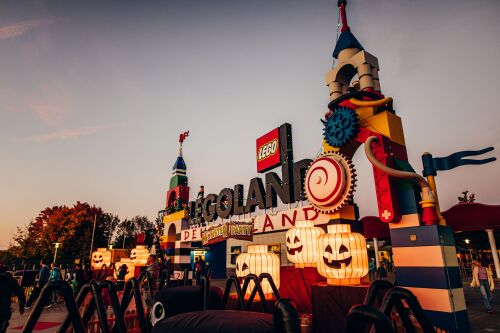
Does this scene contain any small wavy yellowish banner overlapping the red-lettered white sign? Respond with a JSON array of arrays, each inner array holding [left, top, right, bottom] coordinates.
[[201, 221, 253, 246]]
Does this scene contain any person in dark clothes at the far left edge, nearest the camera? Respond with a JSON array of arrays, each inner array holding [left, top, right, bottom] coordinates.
[[0, 265, 26, 333]]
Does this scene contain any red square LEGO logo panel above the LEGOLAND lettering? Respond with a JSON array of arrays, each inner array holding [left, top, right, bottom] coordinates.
[[257, 128, 281, 172]]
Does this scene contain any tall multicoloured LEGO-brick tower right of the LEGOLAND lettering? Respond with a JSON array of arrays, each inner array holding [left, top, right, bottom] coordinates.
[[324, 0, 469, 332]]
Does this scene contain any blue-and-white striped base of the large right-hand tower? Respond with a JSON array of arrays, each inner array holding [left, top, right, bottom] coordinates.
[[390, 213, 469, 332]]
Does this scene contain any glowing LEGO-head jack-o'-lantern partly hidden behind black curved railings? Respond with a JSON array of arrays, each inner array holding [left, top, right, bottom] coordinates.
[[236, 245, 280, 295]]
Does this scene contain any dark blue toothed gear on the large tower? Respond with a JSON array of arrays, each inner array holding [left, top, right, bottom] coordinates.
[[322, 106, 359, 148]]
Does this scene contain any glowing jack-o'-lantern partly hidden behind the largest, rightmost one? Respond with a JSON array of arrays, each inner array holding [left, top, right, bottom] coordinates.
[[286, 221, 325, 268]]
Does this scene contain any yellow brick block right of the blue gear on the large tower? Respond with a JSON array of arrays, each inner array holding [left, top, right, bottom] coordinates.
[[360, 111, 405, 146]]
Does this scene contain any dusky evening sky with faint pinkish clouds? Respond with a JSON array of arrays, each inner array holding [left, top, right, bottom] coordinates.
[[0, 0, 500, 248]]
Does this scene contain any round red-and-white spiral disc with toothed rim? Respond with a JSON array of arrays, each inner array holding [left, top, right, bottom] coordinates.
[[304, 152, 355, 213]]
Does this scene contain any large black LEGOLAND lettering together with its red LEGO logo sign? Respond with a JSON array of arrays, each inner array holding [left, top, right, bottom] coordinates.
[[188, 124, 312, 222]]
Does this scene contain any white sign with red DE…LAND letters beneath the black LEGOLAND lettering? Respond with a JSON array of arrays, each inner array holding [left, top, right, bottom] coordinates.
[[180, 206, 330, 244]]
